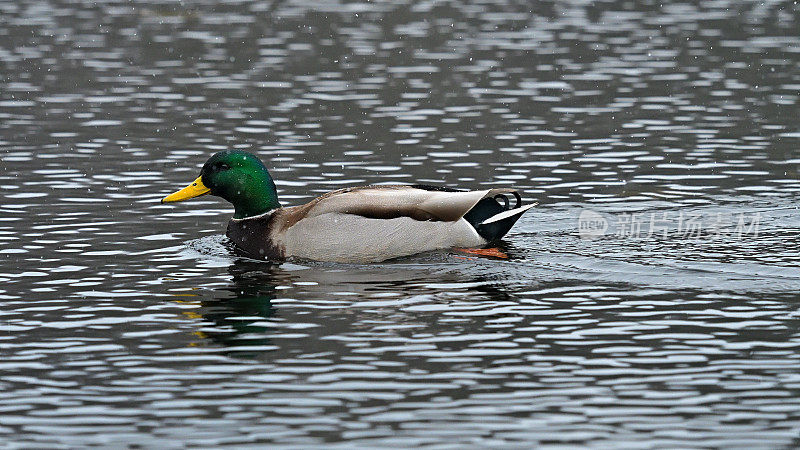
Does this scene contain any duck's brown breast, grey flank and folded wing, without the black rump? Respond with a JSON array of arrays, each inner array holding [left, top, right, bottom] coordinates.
[[228, 186, 527, 263]]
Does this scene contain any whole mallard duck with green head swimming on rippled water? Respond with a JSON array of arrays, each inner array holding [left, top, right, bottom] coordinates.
[[161, 150, 536, 263]]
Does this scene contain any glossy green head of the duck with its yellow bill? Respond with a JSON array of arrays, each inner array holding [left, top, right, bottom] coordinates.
[[161, 150, 280, 219]]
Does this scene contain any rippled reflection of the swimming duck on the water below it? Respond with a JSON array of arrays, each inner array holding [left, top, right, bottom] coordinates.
[[191, 248, 514, 358]]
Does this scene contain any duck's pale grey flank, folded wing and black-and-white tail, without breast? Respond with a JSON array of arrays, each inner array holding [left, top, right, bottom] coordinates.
[[269, 186, 533, 262]]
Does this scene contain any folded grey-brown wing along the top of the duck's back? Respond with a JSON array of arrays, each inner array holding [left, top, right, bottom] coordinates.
[[286, 185, 521, 226]]
